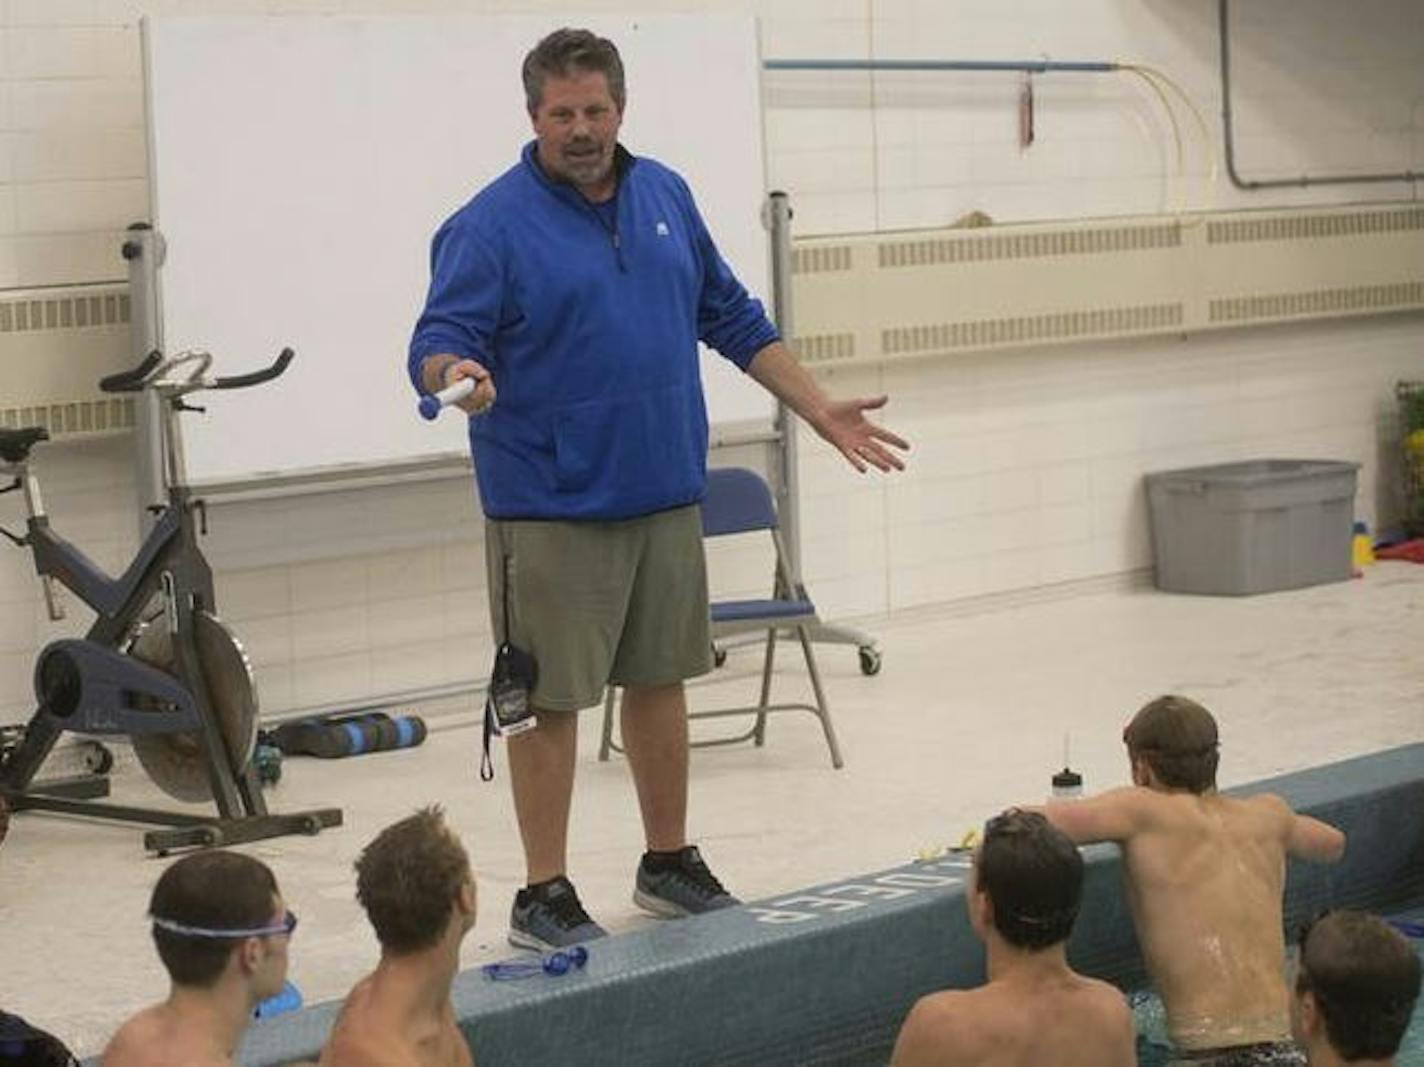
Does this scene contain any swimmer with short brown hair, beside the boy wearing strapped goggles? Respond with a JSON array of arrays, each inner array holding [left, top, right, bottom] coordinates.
[[320, 806, 474, 1067]]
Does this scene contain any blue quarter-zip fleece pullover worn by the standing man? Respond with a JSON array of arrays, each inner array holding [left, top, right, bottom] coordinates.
[[409, 142, 776, 520]]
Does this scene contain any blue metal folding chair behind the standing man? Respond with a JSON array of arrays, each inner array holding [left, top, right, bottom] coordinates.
[[598, 467, 844, 768]]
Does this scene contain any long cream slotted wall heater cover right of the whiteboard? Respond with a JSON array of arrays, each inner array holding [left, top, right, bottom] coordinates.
[[792, 204, 1424, 366]]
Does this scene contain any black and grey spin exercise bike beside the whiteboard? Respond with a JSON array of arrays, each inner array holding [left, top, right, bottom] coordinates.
[[0, 349, 342, 856]]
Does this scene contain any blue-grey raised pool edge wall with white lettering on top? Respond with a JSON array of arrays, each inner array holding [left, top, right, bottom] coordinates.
[[222, 744, 1424, 1067]]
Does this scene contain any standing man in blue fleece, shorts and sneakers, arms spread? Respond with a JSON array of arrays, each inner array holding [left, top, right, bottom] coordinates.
[[409, 30, 909, 949]]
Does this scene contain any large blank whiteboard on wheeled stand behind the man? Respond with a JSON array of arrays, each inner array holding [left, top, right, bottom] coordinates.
[[144, 16, 772, 483]]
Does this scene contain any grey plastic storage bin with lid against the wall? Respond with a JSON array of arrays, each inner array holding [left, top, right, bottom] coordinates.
[[1146, 459, 1360, 595]]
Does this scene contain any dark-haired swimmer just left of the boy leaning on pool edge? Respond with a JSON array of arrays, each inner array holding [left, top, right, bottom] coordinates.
[[891, 809, 1136, 1067]]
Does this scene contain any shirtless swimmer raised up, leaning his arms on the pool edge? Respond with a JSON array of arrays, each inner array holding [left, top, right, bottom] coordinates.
[[1044, 697, 1344, 1067]]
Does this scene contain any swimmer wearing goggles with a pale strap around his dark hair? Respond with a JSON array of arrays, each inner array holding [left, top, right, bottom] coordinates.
[[101, 850, 296, 1067]]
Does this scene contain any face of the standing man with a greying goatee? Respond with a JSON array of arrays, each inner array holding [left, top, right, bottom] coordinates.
[[533, 71, 622, 197]]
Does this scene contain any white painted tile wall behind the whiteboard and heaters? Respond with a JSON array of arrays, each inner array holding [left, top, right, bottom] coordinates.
[[0, 0, 1424, 721]]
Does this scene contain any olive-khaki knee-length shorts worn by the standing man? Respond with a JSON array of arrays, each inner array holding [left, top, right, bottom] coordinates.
[[484, 504, 712, 711]]
